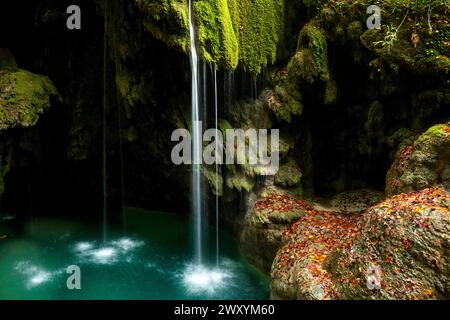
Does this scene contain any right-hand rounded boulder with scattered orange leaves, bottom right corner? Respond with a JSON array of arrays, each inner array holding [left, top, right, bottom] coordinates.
[[329, 188, 450, 299]]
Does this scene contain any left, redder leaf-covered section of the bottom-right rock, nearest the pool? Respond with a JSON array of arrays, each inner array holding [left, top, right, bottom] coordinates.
[[271, 201, 363, 300]]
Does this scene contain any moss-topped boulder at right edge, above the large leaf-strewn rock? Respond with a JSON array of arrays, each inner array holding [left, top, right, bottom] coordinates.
[[386, 124, 450, 195]]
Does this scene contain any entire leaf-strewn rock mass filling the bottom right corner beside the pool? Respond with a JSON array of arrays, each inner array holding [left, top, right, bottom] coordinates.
[[271, 188, 450, 300]]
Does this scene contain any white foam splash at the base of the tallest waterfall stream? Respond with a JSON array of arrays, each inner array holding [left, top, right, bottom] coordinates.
[[183, 264, 232, 294]]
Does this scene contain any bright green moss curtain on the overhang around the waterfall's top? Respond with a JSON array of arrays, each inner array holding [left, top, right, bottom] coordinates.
[[135, 0, 284, 75]]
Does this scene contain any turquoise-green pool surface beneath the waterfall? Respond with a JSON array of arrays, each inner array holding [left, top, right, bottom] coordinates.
[[0, 208, 269, 299]]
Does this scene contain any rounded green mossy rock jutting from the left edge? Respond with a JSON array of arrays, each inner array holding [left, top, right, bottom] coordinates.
[[0, 70, 60, 130]]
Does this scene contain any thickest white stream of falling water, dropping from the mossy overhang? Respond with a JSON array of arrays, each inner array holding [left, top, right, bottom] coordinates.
[[188, 0, 202, 264]]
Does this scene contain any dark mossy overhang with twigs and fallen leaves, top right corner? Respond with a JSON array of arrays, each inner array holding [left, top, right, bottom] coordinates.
[[317, 0, 450, 78]]
